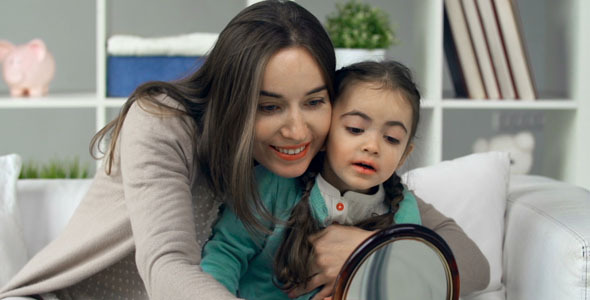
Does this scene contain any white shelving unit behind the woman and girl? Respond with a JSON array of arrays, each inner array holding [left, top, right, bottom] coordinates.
[[0, 0, 590, 188]]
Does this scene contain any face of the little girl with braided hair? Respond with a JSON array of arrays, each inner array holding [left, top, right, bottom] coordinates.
[[322, 82, 413, 193]]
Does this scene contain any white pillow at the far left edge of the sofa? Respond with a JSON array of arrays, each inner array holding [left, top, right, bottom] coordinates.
[[0, 154, 28, 287]]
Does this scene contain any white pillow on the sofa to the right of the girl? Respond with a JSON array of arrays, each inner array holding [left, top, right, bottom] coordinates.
[[402, 152, 510, 299]]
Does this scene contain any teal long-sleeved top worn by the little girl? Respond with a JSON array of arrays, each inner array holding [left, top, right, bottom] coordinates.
[[201, 166, 421, 300]]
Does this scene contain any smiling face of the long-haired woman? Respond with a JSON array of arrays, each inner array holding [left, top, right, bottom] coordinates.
[[253, 47, 332, 178]]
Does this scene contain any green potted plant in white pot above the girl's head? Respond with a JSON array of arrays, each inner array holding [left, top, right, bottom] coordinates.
[[325, 0, 397, 68]]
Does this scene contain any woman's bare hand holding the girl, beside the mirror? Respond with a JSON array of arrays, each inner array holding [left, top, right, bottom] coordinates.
[[289, 225, 373, 300]]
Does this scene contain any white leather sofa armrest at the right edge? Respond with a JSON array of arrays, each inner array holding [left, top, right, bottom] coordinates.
[[504, 175, 590, 300]]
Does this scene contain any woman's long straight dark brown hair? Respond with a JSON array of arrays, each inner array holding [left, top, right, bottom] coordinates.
[[90, 0, 335, 230]]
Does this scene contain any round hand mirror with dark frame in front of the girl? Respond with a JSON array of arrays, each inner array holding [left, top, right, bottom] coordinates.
[[333, 224, 459, 300]]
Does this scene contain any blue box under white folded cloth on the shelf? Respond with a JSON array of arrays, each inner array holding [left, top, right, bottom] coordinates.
[[107, 56, 205, 97]]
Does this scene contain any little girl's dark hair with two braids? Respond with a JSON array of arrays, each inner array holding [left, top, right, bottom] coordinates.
[[274, 61, 420, 290]]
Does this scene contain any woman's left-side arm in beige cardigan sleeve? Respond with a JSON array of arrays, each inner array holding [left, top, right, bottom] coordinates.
[[118, 99, 236, 300]]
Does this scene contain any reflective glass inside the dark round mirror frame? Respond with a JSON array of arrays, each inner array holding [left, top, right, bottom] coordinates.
[[345, 239, 448, 300]]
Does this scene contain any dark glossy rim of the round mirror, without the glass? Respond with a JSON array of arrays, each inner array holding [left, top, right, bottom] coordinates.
[[332, 224, 460, 300]]
